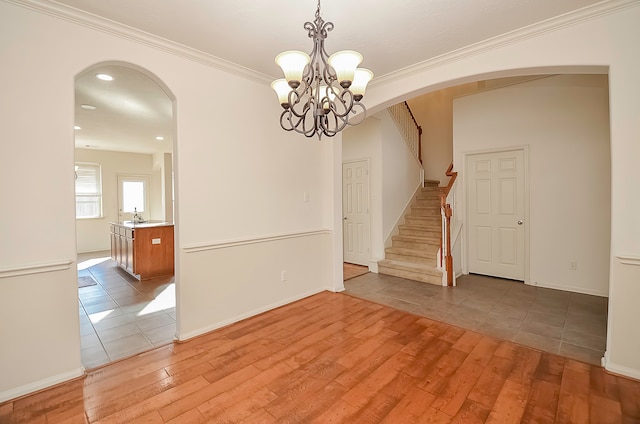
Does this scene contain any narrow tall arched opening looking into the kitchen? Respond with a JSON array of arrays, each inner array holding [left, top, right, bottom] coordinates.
[[74, 62, 176, 368]]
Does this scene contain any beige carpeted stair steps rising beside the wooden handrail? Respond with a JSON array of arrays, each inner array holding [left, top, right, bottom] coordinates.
[[378, 181, 442, 286]]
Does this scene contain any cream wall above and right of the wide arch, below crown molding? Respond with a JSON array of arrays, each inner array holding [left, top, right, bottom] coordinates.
[[360, 0, 640, 378]]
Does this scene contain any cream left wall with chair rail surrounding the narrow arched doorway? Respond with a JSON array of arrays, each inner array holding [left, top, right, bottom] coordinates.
[[0, 2, 342, 401]]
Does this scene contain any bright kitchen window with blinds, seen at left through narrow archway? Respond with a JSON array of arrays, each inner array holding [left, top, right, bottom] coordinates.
[[76, 163, 102, 219]]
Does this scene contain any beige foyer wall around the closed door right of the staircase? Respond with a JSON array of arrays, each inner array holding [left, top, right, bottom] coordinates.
[[453, 75, 611, 296]]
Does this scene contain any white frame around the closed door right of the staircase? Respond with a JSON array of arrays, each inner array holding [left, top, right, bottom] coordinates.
[[461, 145, 531, 285]]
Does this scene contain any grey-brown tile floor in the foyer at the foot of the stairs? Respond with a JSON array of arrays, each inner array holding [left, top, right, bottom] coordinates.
[[344, 273, 608, 365]]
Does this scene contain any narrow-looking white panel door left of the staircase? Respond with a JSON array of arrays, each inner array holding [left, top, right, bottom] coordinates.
[[342, 160, 370, 266]]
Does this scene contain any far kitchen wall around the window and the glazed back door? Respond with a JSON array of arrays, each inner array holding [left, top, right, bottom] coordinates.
[[74, 149, 158, 253]]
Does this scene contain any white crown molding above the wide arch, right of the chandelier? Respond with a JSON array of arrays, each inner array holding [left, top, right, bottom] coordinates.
[[370, 0, 640, 86]]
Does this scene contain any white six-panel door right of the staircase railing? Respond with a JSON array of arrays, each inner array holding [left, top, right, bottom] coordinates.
[[466, 150, 528, 281]]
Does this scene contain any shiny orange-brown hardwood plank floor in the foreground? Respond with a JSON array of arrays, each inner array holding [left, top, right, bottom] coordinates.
[[0, 292, 640, 424]]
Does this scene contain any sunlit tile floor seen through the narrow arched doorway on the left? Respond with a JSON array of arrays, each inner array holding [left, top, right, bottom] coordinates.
[[78, 252, 176, 368]]
